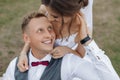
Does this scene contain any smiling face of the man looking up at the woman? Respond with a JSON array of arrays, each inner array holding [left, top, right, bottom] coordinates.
[[25, 17, 55, 52]]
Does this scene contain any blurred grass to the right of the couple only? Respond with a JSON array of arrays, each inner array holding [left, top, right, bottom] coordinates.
[[93, 0, 120, 75]]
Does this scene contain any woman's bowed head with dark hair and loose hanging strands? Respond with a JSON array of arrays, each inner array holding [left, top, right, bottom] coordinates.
[[41, 0, 88, 39]]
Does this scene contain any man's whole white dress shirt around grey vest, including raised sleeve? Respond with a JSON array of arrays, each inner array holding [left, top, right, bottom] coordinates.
[[3, 41, 120, 80]]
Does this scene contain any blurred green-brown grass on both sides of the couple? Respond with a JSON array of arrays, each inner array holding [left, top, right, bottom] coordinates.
[[0, 0, 120, 76]]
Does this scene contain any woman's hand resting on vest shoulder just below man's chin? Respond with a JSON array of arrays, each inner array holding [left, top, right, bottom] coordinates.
[[50, 46, 76, 59]]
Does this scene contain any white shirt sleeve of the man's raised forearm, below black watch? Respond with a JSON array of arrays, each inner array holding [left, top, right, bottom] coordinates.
[[84, 40, 120, 80]]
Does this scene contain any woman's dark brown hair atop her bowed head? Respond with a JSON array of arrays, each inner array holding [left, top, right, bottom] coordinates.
[[41, 0, 88, 16]]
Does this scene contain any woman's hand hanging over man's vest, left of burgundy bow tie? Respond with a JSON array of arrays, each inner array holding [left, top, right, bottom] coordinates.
[[17, 43, 29, 72]]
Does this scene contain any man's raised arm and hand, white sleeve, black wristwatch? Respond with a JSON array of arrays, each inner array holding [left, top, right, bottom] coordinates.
[[78, 9, 119, 80]]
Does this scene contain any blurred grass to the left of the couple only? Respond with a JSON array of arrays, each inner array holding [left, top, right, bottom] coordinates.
[[0, 0, 40, 76]]
